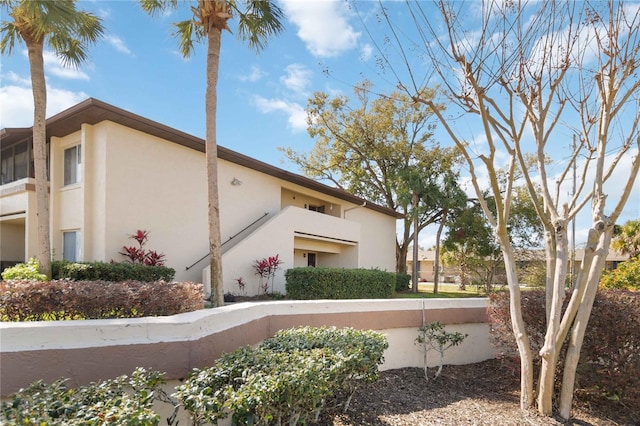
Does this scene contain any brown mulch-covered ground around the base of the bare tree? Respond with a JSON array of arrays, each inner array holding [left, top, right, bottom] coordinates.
[[317, 360, 640, 426]]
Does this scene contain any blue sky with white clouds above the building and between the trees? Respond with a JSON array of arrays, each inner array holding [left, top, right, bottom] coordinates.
[[0, 0, 640, 248]]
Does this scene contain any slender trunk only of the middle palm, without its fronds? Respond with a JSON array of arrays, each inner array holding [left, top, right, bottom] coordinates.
[[205, 26, 224, 307]]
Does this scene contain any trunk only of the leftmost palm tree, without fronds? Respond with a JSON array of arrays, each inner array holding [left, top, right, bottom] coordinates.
[[27, 43, 51, 278]]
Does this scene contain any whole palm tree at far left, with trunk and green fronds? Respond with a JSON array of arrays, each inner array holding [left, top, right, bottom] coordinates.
[[0, 0, 103, 277]]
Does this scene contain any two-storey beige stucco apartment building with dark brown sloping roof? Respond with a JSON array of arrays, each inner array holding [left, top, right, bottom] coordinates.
[[0, 98, 398, 294]]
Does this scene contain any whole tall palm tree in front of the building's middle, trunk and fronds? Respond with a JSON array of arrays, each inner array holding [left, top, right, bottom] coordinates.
[[140, 0, 284, 306]]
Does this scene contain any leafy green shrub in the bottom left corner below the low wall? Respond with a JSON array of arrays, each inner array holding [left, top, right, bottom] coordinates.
[[0, 368, 165, 425]]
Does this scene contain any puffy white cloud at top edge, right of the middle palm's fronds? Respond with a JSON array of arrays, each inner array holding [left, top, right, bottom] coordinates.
[[281, 0, 360, 57]]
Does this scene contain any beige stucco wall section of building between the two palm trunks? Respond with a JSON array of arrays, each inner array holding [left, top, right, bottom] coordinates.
[[51, 121, 207, 282]]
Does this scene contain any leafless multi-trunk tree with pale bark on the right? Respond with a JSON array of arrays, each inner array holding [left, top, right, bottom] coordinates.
[[370, 0, 640, 418]]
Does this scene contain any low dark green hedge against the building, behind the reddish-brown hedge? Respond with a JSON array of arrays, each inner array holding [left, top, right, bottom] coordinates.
[[51, 260, 176, 282]]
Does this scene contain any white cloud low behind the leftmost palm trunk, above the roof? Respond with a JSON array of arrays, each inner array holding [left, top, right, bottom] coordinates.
[[0, 73, 88, 129]]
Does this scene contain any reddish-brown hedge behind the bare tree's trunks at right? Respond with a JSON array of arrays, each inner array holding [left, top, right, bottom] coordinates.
[[488, 290, 640, 410]]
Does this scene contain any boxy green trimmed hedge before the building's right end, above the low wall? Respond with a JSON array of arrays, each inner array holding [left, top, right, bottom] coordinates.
[[285, 267, 396, 300]]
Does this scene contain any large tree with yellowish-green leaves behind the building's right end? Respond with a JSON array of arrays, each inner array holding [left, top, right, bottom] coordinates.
[[282, 81, 460, 273]]
